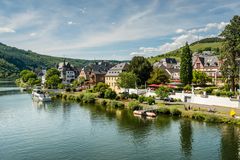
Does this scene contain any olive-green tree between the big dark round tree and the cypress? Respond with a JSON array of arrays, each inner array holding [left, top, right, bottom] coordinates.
[[147, 68, 169, 84]]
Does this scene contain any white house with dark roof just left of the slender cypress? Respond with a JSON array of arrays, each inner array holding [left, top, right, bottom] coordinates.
[[153, 58, 180, 80]]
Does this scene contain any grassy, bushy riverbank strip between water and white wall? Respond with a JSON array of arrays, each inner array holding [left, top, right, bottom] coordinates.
[[53, 92, 240, 125]]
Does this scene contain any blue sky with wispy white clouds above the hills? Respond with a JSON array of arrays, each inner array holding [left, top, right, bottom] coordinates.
[[0, 0, 240, 60]]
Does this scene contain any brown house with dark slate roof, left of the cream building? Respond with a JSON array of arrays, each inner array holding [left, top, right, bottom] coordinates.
[[78, 61, 113, 86]]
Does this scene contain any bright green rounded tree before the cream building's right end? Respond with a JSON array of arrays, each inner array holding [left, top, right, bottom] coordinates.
[[117, 72, 138, 88]]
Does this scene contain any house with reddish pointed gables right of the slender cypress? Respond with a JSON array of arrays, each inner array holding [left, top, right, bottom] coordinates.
[[192, 54, 222, 83]]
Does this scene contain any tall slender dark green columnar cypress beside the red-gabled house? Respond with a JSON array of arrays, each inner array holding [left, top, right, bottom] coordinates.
[[180, 42, 193, 85]]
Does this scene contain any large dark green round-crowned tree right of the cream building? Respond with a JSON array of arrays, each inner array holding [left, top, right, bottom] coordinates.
[[128, 56, 153, 85]]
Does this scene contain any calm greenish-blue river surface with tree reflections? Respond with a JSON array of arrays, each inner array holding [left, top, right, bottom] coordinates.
[[0, 83, 240, 160]]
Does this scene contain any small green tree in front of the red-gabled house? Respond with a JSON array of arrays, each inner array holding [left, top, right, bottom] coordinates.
[[192, 70, 212, 86]]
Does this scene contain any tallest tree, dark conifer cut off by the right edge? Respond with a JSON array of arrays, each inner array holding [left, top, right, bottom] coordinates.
[[220, 16, 240, 91]]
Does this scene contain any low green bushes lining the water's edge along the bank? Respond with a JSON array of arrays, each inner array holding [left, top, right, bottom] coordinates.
[[54, 92, 240, 125]]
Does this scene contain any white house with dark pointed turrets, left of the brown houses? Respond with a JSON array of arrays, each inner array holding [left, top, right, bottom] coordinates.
[[57, 60, 78, 84]]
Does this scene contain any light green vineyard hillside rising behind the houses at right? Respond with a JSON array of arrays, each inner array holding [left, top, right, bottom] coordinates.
[[149, 37, 223, 63]]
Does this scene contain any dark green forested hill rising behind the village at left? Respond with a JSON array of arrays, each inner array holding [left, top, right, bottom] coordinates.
[[0, 43, 116, 79]]
